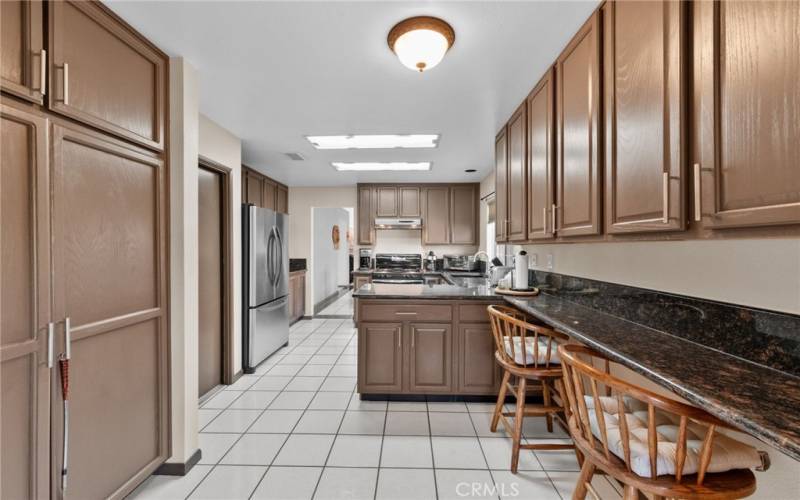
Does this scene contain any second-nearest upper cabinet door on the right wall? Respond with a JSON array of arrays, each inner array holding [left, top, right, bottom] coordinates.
[[603, 0, 687, 233]]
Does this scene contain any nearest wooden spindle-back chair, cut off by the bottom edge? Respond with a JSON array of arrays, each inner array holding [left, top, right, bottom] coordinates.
[[559, 344, 768, 499]]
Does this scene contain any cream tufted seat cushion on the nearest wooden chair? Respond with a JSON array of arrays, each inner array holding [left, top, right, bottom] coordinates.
[[584, 396, 762, 477]]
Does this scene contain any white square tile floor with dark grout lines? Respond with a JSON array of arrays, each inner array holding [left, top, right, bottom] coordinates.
[[131, 319, 620, 500]]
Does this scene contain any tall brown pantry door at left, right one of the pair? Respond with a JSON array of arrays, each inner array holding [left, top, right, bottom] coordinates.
[[51, 123, 169, 498]]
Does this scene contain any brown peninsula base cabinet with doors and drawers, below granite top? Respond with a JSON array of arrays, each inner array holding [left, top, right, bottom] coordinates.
[[356, 299, 500, 396]]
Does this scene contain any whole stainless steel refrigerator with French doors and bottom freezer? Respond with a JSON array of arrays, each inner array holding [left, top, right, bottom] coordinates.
[[242, 205, 289, 373]]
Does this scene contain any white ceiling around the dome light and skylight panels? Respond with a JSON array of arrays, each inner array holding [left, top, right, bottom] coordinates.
[[107, 0, 597, 186]]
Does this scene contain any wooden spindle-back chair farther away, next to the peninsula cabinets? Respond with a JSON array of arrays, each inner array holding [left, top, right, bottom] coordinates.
[[487, 305, 574, 473]]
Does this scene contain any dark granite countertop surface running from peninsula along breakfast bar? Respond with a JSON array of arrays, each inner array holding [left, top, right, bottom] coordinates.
[[353, 274, 800, 460]]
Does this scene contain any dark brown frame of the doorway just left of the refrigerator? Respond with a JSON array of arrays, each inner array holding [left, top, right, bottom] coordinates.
[[197, 155, 236, 385]]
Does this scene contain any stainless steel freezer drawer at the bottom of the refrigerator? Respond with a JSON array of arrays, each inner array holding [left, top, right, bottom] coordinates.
[[247, 296, 289, 368]]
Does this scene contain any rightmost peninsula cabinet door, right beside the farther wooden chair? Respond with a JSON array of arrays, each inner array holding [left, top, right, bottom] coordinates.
[[458, 323, 500, 394]]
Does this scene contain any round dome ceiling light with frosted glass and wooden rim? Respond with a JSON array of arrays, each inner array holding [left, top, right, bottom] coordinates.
[[387, 16, 456, 73]]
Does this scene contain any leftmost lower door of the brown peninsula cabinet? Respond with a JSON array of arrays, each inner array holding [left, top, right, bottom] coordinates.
[[358, 323, 403, 393]]
